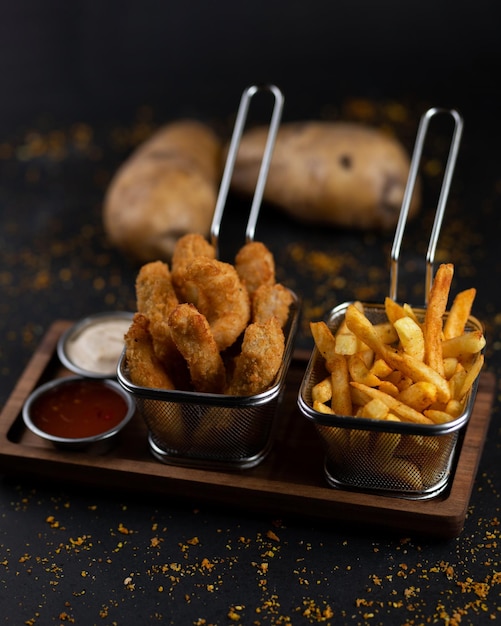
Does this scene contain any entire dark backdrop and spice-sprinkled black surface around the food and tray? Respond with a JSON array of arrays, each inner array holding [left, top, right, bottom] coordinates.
[[0, 0, 501, 626]]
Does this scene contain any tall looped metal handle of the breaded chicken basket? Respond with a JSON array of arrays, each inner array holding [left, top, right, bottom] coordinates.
[[210, 85, 284, 255]]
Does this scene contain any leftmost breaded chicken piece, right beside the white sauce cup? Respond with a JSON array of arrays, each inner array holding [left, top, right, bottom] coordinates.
[[124, 313, 174, 389]]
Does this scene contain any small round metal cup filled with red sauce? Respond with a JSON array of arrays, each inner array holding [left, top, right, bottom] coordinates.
[[23, 376, 135, 449]]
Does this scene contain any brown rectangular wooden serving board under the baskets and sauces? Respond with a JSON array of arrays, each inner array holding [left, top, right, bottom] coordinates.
[[0, 321, 495, 538]]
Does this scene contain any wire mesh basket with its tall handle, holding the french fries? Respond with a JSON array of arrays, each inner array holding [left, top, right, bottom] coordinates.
[[298, 109, 483, 499]]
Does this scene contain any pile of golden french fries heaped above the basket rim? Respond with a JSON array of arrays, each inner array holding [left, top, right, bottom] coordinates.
[[310, 264, 485, 424]]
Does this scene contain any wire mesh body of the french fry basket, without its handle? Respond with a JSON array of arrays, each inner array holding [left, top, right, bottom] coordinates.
[[298, 303, 482, 499]]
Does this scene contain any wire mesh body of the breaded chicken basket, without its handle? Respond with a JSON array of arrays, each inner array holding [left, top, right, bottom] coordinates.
[[117, 295, 299, 469]]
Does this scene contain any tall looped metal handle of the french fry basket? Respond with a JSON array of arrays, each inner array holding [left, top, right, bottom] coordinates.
[[390, 108, 463, 304]]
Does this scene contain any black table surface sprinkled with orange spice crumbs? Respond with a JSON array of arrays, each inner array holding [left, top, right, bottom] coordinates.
[[0, 100, 501, 624]]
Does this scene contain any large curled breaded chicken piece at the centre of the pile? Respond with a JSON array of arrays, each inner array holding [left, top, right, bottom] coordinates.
[[184, 257, 251, 352]]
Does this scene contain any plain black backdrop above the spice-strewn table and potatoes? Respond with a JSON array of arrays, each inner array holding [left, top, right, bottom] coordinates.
[[0, 0, 500, 129]]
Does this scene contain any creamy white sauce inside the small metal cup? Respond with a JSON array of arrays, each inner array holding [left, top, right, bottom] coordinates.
[[66, 318, 131, 375]]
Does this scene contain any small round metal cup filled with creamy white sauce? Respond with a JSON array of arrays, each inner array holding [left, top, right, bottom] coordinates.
[[57, 311, 133, 378]]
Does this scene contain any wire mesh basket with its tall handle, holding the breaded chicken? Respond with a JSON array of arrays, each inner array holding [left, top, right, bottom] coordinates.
[[117, 85, 300, 469]]
